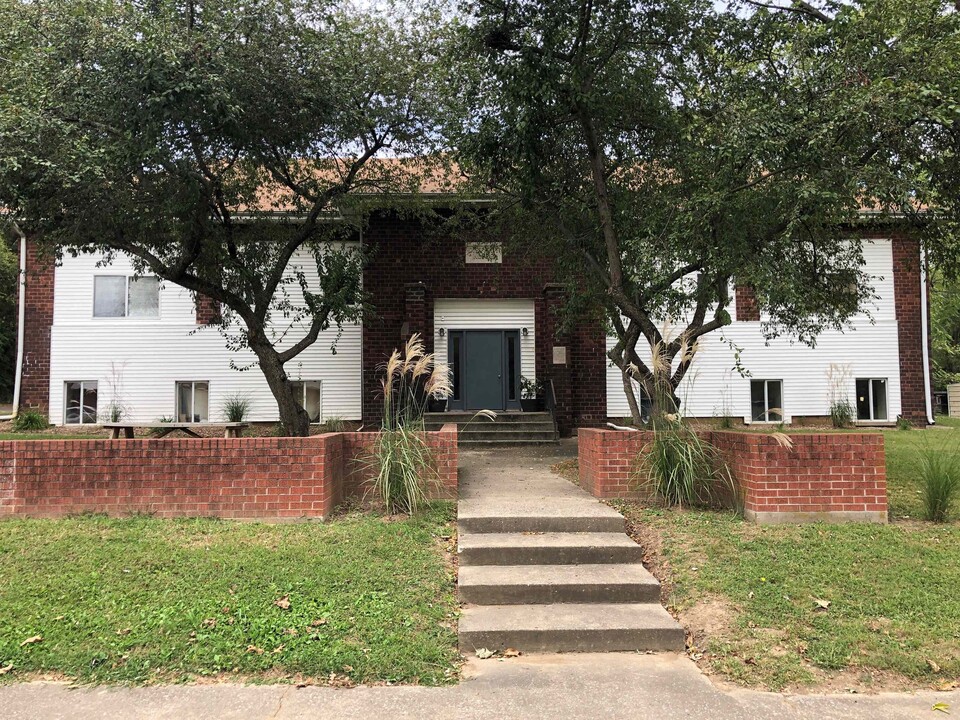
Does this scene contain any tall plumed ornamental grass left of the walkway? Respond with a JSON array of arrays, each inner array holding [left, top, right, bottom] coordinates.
[[372, 335, 450, 513]]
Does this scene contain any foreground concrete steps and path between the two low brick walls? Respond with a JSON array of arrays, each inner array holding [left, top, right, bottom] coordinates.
[[458, 452, 684, 653]]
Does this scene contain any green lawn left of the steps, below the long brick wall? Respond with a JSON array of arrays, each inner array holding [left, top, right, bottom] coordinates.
[[0, 503, 458, 685]]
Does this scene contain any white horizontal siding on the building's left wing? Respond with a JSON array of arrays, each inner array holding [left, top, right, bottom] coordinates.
[[50, 254, 361, 423]]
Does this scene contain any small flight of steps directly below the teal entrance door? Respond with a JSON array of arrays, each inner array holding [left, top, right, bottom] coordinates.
[[423, 411, 558, 448]]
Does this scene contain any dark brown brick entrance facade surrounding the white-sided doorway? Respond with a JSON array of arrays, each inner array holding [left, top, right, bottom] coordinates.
[[363, 215, 606, 434]]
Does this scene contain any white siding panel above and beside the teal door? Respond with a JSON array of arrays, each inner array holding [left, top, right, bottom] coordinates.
[[433, 298, 537, 380]]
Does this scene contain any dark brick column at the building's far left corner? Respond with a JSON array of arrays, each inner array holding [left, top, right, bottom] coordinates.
[[17, 242, 55, 411]]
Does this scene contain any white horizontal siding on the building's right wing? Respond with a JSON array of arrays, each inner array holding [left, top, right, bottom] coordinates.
[[607, 240, 900, 423]]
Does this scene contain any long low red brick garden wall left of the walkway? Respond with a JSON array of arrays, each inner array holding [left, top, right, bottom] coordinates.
[[0, 425, 458, 520]]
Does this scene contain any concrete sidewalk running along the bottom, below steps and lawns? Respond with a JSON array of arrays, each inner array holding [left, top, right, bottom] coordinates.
[[0, 653, 960, 720]]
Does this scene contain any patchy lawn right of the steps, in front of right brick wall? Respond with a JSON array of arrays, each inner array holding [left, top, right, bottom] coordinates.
[[622, 506, 960, 689]]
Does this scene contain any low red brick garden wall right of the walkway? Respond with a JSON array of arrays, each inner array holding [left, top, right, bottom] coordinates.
[[579, 428, 887, 523]]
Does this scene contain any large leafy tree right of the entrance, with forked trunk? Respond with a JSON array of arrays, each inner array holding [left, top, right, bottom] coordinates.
[[450, 0, 960, 422]]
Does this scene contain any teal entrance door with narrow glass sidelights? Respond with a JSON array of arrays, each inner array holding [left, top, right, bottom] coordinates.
[[447, 330, 520, 412]]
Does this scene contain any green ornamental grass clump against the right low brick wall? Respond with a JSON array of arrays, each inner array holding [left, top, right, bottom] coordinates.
[[639, 416, 740, 509]]
